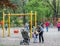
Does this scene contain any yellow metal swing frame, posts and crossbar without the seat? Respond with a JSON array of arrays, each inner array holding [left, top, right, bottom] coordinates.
[[2, 11, 37, 38]]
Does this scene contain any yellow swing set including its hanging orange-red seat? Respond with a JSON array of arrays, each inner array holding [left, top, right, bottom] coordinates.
[[1, 11, 36, 38]]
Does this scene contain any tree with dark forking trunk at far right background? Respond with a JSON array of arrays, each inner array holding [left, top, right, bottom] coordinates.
[[46, 0, 59, 25]]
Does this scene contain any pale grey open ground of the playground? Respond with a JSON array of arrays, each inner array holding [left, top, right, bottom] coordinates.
[[0, 28, 60, 46]]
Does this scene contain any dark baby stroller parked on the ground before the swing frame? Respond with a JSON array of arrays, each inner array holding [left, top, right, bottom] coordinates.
[[20, 30, 30, 45]]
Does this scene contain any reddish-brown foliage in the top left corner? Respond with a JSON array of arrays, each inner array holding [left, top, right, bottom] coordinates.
[[0, 0, 17, 9]]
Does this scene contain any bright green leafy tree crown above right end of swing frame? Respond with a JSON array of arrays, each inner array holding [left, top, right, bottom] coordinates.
[[25, 0, 52, 20]]
